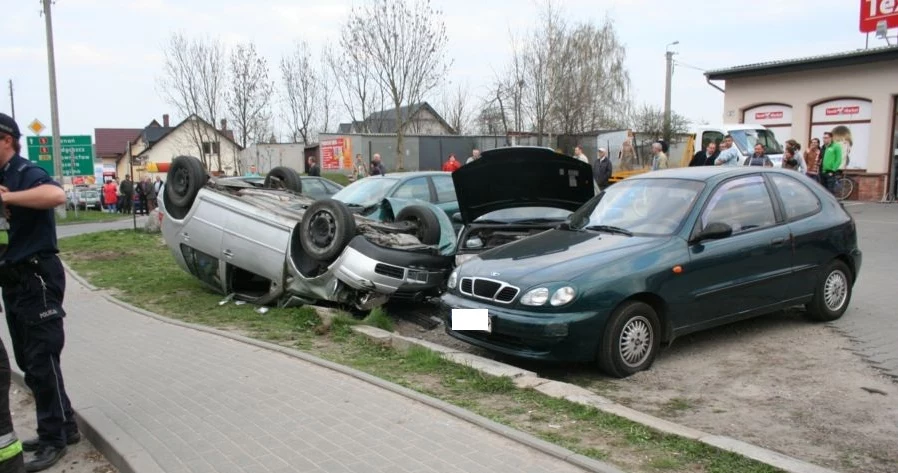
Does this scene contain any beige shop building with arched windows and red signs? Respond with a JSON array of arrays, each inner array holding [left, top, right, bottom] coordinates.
[[705, 46, 898, 201]]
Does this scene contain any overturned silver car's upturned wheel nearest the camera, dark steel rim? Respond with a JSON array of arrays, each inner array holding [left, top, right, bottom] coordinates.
[[299, 199, 355, 262]]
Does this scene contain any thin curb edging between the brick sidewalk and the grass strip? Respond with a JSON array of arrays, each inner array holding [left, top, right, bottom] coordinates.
[[82, 269, 624, 473]]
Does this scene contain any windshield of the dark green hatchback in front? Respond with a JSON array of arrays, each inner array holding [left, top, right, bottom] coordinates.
[[571, 179, 705, 236]]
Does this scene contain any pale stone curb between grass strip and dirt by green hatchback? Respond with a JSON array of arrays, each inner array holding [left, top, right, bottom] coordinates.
[[352, 326, 838, 473]]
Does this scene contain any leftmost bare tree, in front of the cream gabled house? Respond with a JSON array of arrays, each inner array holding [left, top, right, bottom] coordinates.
[[158, 33, 227, 172]]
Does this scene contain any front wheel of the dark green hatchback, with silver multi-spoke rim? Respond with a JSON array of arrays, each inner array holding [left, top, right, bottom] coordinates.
[[598, 301, 661, 378]]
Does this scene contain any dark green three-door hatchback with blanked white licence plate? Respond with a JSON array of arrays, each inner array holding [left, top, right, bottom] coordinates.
[[442, 167, 861, 377]]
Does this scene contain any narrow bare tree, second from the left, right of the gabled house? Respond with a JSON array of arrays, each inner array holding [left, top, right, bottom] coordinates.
[[227, 43, 274, 148]]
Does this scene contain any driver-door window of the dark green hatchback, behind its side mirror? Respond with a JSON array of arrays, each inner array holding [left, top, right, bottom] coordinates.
[[702, 176, 776, 234]]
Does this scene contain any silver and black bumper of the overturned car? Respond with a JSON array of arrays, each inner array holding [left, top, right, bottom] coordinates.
[[334, 236, 452, 295]]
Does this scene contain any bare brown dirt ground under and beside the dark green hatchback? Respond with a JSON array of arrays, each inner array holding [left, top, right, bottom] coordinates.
[[397, 306, 898, 473]]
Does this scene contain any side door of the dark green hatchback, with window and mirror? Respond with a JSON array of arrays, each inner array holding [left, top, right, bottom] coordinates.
[[683, 174, 792, 326]]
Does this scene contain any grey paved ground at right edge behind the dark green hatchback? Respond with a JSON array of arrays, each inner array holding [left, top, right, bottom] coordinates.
[[832, 203, 898, 380]]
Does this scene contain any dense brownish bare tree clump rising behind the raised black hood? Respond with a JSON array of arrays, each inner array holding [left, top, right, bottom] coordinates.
[[499, 0, 630, 143]]
